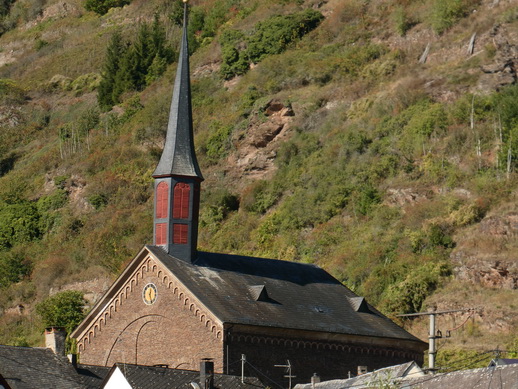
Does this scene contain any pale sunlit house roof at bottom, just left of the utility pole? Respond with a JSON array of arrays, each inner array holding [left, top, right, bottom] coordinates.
[[294, 362, 424, 389]]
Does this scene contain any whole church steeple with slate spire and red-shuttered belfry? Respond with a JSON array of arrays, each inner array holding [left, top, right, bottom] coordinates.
[[153, 0, 203, 262]]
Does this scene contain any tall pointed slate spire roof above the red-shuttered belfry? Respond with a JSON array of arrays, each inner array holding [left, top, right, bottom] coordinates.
[[153, 4, 203, 180]]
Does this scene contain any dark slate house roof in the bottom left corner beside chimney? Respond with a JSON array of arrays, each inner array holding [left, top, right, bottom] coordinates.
[[0, 346, 85, 389]]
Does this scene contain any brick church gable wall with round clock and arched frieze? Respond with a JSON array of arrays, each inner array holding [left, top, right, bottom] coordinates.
[[72, 249, 223, 369]]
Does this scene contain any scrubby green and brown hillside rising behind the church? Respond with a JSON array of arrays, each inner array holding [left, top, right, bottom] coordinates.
[[0, 0, 518, 368]]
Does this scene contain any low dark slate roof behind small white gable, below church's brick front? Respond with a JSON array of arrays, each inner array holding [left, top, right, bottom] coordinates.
[[104, 363, 264, 389]]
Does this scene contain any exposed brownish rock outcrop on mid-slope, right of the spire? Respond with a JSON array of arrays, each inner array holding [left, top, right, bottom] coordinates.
[[230, 99, 295, 178]]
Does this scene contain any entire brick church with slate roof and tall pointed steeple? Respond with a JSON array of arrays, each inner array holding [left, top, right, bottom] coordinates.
[[71, 0, 427, 383]]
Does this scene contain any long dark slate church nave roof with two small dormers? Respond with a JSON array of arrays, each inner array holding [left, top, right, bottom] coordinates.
[[146, 246, 425, 347]]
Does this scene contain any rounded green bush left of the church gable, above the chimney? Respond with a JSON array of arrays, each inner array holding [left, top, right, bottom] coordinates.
[[36, 290, 86, 334]]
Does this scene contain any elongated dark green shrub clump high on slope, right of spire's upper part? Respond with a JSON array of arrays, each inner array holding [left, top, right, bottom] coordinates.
[[220, 9, 324, 79]]
